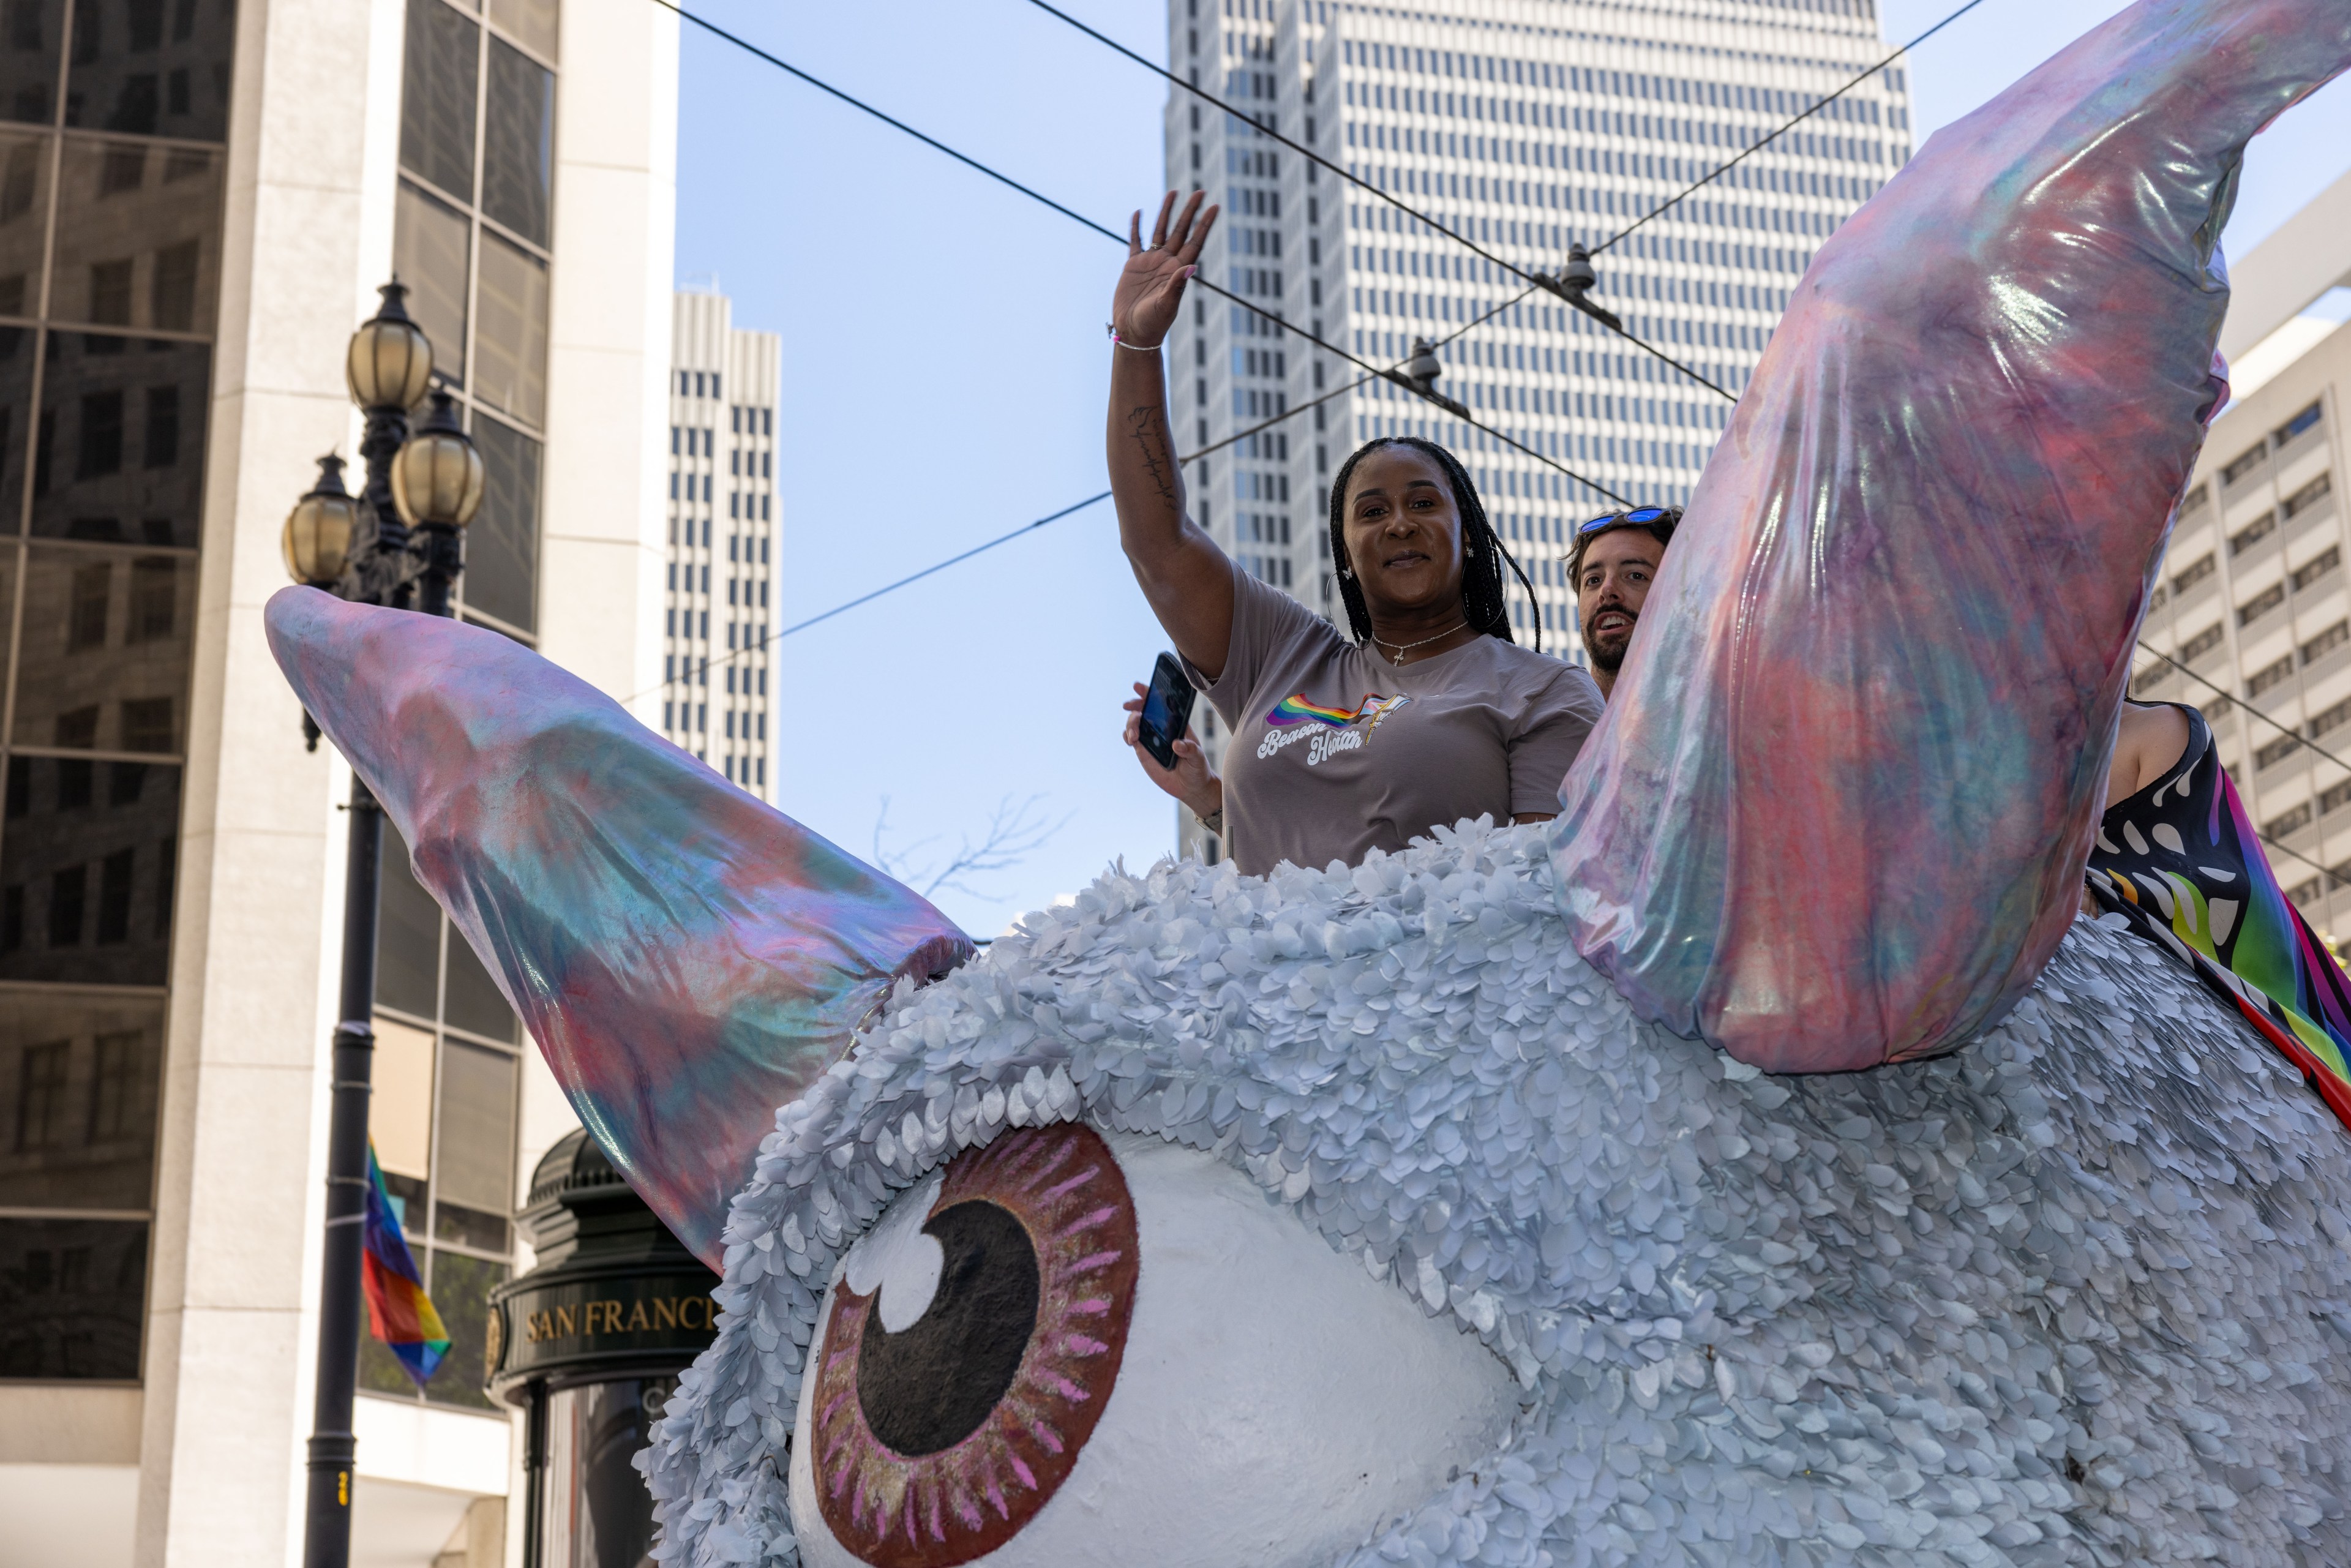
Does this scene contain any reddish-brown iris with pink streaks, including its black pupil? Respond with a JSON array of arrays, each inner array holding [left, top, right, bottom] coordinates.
[[809, 1121, 1138, 1568]]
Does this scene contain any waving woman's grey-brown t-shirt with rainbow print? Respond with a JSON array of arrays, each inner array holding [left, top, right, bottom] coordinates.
[[1185, 569, 1601, 874]]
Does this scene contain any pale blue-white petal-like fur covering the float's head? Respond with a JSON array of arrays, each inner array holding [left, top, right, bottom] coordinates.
[[639, 825, 2351, 1568]]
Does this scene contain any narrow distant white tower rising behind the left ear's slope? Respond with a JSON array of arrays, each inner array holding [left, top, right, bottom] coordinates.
[[661, 291, 783, 801]]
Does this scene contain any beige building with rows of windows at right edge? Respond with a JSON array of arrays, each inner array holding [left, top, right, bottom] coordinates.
[[2130, 174, 2351, 950]]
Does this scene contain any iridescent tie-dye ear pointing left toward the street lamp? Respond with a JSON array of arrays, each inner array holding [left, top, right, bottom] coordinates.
[[268, 588, 971, 1267]]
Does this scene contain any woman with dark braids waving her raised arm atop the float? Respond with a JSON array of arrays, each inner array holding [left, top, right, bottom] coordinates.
[[1108, 193, 1601, 874]]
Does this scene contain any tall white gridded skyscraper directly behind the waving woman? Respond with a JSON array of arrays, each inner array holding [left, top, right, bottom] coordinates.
[[1166, 0, 1909, 853]]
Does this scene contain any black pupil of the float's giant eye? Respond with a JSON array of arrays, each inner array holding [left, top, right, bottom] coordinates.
[[858, 1199, 1037, 1460]]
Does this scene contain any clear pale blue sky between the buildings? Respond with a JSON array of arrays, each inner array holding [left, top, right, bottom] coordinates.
[[677, 0, 2351, 933]]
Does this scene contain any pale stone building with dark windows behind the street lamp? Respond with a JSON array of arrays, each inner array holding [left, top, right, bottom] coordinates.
[[0, 0, 677, 1568]]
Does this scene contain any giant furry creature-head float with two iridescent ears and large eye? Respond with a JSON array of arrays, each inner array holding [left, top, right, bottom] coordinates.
[[271, 0, 2351, 1568]]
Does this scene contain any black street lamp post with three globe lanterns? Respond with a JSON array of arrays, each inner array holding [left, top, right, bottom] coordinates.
[[282, 282, 482, 1568]]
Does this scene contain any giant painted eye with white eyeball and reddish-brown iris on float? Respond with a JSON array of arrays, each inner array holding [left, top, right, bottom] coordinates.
[[790, 1123, 1517, 1568]]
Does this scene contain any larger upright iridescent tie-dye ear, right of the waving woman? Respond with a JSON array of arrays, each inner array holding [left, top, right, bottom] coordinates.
[[1551, 0, 2351, 1072]]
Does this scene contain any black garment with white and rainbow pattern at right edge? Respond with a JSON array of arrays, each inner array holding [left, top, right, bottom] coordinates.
[[2090, 703, 2351, 1126]]
